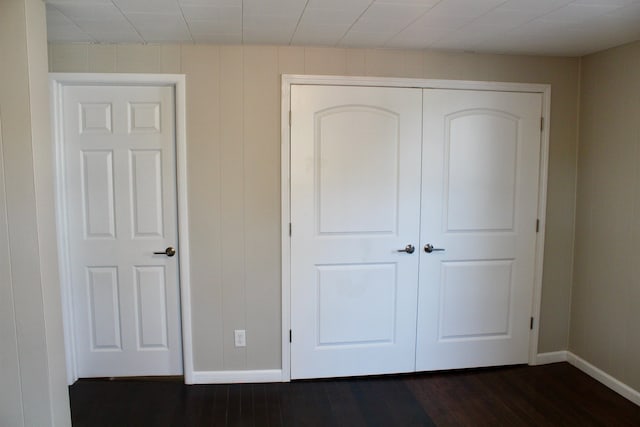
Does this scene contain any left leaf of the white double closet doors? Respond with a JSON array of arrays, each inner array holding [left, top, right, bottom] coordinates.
[[291, 85, 422, 379]]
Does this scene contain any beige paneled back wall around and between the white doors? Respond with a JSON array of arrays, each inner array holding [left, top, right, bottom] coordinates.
[[49, 44, 579, 371]]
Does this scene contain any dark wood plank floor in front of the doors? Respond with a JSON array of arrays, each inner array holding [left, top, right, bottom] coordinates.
[[70, 363, 640, 427]]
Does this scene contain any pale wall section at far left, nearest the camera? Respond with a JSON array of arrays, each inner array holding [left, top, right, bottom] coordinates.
[[0, 0, 71, 426]]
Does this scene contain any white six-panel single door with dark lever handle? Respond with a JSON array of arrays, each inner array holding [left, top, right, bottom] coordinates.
[[63, 86, 182, 377]]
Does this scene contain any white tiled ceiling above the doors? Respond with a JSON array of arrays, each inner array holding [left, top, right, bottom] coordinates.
[[46, 0, 640, 56]]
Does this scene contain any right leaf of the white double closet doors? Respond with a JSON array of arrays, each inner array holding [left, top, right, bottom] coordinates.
[[416, 89, 542, 371]]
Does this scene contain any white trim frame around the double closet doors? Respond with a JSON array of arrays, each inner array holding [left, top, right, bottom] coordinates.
[[280, 74, 551, 381]]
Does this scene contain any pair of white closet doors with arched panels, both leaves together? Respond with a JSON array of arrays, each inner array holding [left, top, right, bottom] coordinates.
[[290, 85, 542, 379]]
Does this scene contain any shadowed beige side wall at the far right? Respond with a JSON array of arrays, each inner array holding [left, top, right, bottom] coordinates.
[[569, 42, 640, 390]]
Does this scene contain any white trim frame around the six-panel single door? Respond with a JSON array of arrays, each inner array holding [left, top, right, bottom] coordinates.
[[49, 73, 193, 385]]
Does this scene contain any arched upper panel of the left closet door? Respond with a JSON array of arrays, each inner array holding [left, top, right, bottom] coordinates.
[[315, 105, 400, 234]]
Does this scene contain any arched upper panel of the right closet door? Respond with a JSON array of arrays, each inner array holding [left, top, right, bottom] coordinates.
[[445, 109, 518, 231]]
